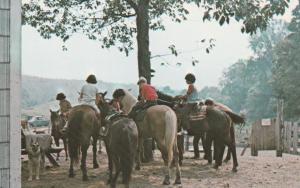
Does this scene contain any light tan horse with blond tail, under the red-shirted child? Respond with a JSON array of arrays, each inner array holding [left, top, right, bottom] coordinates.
[[113, 89, 181, 185]]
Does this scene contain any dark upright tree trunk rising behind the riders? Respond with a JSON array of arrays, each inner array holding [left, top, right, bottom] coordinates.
[[136, 0, 151, 83]]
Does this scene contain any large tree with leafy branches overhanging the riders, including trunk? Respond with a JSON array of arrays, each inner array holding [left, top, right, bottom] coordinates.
[[22, 0, 288, 81]]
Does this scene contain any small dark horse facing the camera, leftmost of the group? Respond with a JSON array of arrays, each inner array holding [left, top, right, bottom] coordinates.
[[50, 110, 68, 161]]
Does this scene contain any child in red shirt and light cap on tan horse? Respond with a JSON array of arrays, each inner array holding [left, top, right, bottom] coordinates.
[[129, 77, 158, 118]]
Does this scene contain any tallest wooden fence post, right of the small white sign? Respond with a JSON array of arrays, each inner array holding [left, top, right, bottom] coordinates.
[[275, 99, 283, 157]]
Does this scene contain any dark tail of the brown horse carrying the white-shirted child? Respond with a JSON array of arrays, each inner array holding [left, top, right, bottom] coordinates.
[[68, 113, 83, 164]]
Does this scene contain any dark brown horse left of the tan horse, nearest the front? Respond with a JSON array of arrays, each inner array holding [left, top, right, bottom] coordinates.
[[98, 94, 138, 188]]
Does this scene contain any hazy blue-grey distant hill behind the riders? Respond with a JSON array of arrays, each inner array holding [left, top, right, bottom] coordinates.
[[22, 75, 181, 115]]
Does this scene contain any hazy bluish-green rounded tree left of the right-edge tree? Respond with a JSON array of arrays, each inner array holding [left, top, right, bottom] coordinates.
[[221, 21, 288, 120]]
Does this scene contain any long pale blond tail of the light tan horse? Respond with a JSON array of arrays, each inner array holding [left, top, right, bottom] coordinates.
[[165, 110, 177, 160]]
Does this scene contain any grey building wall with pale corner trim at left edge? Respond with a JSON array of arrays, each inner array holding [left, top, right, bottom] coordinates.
[[0, 0, 21, 188]]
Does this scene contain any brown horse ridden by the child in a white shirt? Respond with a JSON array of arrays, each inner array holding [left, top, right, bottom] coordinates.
[[67, 105, 101, 181]]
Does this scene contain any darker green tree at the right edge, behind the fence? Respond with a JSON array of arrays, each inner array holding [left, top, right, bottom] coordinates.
[[273, 5, 300, 120]]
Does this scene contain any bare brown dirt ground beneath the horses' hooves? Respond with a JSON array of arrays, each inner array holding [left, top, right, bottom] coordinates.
[[22, 145, 300, 188]]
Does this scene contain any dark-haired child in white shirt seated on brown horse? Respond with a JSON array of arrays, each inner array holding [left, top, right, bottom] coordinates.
[[78, 74, 100, 118]]
